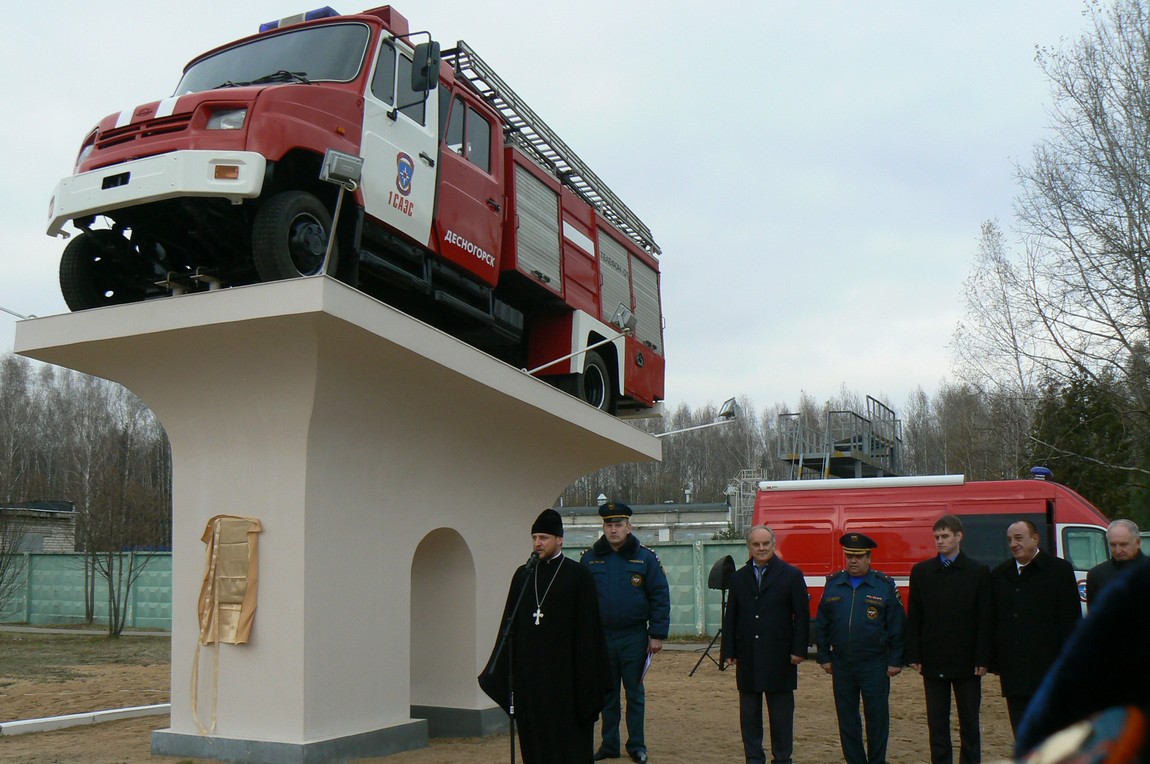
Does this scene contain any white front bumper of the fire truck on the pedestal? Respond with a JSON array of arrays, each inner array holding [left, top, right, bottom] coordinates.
[[48, 151, 268, 238]]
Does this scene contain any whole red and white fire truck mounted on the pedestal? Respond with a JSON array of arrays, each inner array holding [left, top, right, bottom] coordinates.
[[48, 6, 665, 414]]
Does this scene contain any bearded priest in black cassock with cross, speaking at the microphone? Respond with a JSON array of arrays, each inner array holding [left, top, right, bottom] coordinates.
[[480, 509, 611, 764]]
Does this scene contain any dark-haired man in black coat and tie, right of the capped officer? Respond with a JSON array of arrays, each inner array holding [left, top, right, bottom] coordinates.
[[906, 514, 991, 764]]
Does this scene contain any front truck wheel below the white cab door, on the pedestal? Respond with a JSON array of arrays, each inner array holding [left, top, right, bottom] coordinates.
[[252, 191, 339, 281]]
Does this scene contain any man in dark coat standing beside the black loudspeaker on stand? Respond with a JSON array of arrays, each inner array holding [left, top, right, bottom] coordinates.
[[720, 525, 811, 764]]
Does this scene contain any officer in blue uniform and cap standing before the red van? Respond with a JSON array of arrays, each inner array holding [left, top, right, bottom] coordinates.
[[814, 533, 906, 764]]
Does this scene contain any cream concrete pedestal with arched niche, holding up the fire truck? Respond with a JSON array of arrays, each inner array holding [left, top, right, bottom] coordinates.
[[16, 277, 661, 764]]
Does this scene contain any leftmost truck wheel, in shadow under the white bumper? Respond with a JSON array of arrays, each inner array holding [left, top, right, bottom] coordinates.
[[60, 230, 145, 311]]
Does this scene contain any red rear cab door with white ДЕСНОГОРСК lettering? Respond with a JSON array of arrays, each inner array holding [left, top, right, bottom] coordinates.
[[436, 90, 504, 287]]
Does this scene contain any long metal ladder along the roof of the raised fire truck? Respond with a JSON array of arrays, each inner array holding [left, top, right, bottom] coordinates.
[[443, 40, 662, 255]]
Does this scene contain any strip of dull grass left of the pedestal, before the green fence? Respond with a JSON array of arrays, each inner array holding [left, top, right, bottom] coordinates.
[[0, 632, 171, 685]]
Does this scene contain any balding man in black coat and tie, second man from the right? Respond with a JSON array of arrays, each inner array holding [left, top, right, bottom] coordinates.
[[990, 520, 1082, 733]]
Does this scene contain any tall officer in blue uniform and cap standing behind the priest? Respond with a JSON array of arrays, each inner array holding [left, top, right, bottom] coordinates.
[[580, 502, 670, 764]]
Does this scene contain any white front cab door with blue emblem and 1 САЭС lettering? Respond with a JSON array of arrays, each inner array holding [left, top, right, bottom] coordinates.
[[362, 39, 439, 245]]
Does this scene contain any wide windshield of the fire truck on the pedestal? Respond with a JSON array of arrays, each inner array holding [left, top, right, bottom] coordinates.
[[175, 24, 370, 96]]
